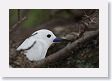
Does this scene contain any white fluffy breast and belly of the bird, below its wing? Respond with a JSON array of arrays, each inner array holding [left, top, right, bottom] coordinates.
[[25, 40, 47, 61]]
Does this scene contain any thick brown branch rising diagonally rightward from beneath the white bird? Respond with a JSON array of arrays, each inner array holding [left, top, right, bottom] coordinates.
[[30, 30, 99, 68]]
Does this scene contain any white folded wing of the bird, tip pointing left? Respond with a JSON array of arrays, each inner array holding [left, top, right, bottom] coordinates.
[[17, 37, 36, 51]]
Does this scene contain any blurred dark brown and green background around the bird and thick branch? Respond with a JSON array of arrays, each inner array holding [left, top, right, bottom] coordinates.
[[9, 9, 99, 68]]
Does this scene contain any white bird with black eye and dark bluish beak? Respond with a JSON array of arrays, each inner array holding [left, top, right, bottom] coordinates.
[[17, 29, 61, 61]]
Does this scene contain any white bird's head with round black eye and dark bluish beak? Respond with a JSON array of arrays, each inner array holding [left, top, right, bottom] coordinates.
[[32, 29, 63, 45]]
